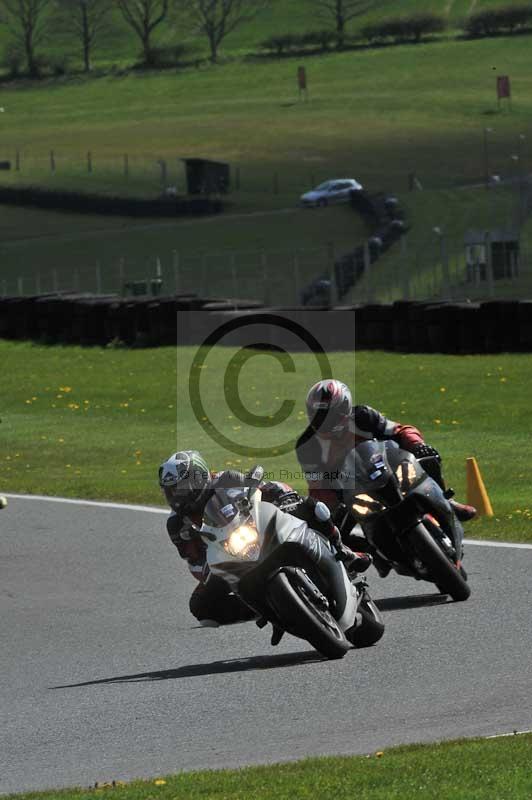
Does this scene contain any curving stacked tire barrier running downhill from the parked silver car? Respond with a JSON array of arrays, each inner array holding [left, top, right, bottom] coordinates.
[[301, 191, 408, 306]]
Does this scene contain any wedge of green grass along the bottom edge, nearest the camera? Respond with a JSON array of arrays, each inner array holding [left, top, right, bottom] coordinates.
[[7, 734, 532, 800]]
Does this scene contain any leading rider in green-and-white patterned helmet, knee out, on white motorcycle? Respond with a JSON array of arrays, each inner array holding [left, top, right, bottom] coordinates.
[[159, 450, 371, 627]]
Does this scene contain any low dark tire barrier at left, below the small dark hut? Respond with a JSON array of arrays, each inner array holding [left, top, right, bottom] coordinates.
[[0, 186, 223, 217]]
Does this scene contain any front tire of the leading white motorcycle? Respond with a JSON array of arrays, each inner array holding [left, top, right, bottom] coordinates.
[[267, 572, 351, 659]]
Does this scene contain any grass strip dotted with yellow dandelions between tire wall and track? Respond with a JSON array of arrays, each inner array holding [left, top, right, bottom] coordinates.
[[0, 342, 532, 541]]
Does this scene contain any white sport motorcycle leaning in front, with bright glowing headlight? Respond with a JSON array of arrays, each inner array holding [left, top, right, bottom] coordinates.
[[194, 482, 384, 659]]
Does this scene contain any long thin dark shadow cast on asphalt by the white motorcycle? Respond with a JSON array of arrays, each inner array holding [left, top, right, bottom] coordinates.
[[48, 650, 326, 689]]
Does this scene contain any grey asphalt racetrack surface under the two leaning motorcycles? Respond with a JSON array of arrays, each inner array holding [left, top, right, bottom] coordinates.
[[0, 498, 532, 793]]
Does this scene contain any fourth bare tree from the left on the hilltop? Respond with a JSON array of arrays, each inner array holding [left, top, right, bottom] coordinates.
[[183, 0, 270, 63]]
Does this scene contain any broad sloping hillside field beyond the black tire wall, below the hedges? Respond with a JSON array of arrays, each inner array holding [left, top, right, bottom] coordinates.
[[0, 27, 532, 301]]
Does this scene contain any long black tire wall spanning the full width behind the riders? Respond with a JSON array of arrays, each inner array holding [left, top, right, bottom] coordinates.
[[0, 293, 532, 354]]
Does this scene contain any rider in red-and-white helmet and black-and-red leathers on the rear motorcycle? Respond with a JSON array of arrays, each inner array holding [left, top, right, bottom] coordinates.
[[296, 380, 477, 532]]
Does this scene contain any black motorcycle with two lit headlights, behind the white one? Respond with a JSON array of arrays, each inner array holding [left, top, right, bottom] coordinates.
[[336, 440, 471, 600]]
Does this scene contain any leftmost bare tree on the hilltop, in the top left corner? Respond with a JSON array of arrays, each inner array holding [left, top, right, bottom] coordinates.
[[0, 0, 52, 76]]
